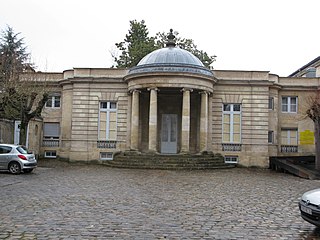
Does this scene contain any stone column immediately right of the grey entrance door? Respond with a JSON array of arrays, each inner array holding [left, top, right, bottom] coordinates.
[[181, 88, 192, 153]]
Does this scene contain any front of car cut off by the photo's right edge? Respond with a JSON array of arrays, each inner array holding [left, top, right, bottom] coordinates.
[[299, 188, 320, 227]]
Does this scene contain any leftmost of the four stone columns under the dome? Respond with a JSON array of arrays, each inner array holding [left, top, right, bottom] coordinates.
[[130, 90, 140, 150]]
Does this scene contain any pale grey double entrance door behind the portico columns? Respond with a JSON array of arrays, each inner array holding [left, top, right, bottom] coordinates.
[[161, 114, 178, 154]]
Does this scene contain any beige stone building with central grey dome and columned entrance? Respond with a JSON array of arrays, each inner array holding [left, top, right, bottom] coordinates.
[[21, 35, 320, 167]]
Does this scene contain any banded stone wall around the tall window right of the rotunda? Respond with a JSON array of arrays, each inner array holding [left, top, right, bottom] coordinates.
[[212, 82, 269, 167]]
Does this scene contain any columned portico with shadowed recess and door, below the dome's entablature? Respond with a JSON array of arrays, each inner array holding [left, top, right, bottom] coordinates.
[[130, 88, 209, 154]]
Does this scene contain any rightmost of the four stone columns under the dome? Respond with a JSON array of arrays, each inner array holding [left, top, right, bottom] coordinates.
[[200, 91, 209, 152]]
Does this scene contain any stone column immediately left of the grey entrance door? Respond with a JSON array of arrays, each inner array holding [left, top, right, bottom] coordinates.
[[148, 88, 158, 152]]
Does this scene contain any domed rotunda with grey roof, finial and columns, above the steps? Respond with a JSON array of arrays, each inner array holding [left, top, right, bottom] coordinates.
[[124, 29, 216, 154]]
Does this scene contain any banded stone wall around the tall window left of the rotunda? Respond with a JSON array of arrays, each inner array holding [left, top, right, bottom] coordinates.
[[63, 79, 128, 161]]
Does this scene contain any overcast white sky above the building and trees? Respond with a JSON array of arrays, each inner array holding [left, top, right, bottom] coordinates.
[[0, 0, 320, 76]]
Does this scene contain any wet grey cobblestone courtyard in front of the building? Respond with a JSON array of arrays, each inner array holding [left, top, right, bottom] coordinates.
[[0, 161, 320, 239]]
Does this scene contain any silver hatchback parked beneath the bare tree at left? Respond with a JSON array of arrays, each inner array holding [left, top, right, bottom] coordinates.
[[0, 144, 37, 174]]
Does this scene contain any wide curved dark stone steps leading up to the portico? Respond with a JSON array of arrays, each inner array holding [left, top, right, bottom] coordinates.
[[102, 151, 235, 170]]
